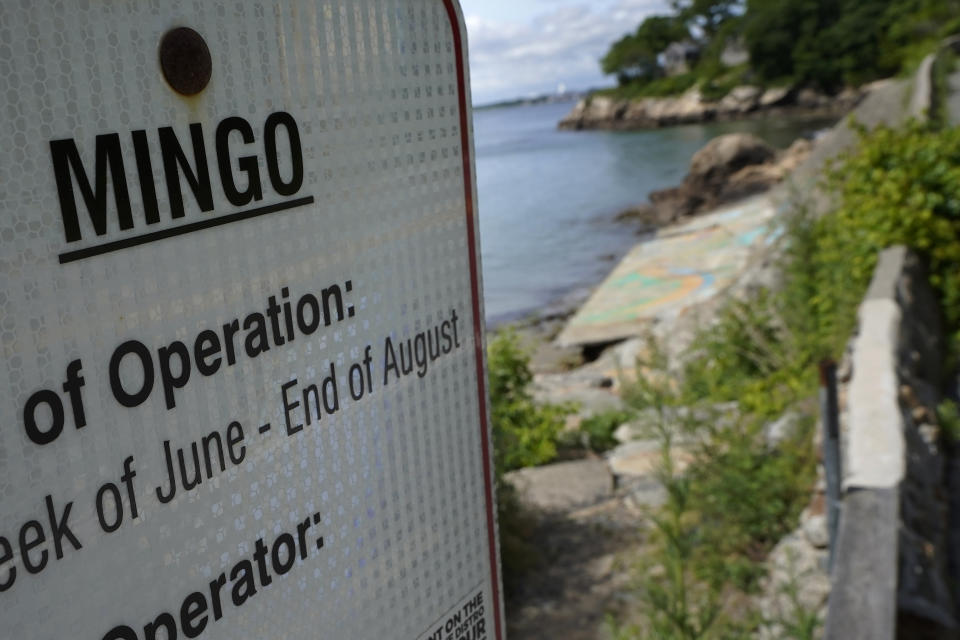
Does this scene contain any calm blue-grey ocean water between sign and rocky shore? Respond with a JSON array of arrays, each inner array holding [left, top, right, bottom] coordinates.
[[474, 104, 830, 324]]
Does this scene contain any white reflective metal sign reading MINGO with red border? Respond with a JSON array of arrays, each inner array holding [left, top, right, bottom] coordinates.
[[0, 0, 502, 640]]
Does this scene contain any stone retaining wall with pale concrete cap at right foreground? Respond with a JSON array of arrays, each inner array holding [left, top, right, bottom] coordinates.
[[825, 247, 960, 640]]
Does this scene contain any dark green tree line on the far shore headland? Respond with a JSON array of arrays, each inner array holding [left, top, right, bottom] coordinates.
[[600, 0, 960, 98]]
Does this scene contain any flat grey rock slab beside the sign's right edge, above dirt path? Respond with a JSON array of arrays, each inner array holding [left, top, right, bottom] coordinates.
[[504, 460, 613, 511]]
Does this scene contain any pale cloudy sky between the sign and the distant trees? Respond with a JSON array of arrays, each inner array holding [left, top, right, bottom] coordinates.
[[460, 0, 668, 105]]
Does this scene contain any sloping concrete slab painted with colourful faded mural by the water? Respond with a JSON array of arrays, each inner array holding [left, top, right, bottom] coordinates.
[[557, 195, 777, 346]]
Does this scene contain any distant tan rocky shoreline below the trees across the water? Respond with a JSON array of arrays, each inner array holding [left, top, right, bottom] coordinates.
[[557, 85, 867, 131]]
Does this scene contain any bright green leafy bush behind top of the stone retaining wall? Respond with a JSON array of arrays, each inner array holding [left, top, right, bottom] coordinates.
[[812, 123, 960, 326]]
